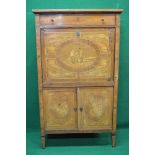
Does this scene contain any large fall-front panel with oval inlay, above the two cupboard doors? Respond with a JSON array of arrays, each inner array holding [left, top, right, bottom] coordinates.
[[42, 28, 115, 84]]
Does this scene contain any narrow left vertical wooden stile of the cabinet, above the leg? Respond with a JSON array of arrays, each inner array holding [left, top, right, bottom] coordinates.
[[35, 15, 45, 136]]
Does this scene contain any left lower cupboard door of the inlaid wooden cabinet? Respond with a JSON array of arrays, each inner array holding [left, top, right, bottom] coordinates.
[[43, 88, 77, 130]]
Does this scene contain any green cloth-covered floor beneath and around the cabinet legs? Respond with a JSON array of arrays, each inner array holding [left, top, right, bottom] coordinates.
[[26, 128, 129, 155]]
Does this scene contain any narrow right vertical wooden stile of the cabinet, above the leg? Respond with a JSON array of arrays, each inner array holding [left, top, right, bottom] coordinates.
[[113, 15, 120, 133]]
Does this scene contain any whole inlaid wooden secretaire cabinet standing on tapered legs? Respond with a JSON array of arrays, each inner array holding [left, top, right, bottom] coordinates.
[[33, 9, 122, 148]]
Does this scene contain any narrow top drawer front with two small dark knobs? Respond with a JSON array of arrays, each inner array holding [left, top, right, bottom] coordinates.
[[40, 14, 115, 26]]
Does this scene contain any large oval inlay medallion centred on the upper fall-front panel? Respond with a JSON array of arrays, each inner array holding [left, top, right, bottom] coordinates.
[[56, 39, 99, 72]]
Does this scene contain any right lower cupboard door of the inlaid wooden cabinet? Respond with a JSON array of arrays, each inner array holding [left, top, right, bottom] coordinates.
[[78, 87, 113, 130]]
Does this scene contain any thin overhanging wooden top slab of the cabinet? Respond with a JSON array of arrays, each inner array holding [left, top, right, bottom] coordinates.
[[32, 9, 123, 14]]
